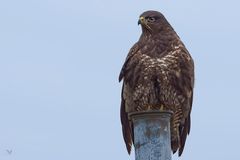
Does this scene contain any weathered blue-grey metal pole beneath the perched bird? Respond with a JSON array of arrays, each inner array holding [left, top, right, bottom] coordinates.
[[129, 111, 172, 160]]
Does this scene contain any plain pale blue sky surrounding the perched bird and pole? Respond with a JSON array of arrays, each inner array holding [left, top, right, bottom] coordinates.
[[0, 0, 240, 160]]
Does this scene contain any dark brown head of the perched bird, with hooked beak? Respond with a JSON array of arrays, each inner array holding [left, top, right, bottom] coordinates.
[[138, 11, 170, 34]]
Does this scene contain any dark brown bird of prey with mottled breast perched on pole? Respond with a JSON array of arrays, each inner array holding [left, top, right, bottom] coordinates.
[[119, 11, 194, 156]]
